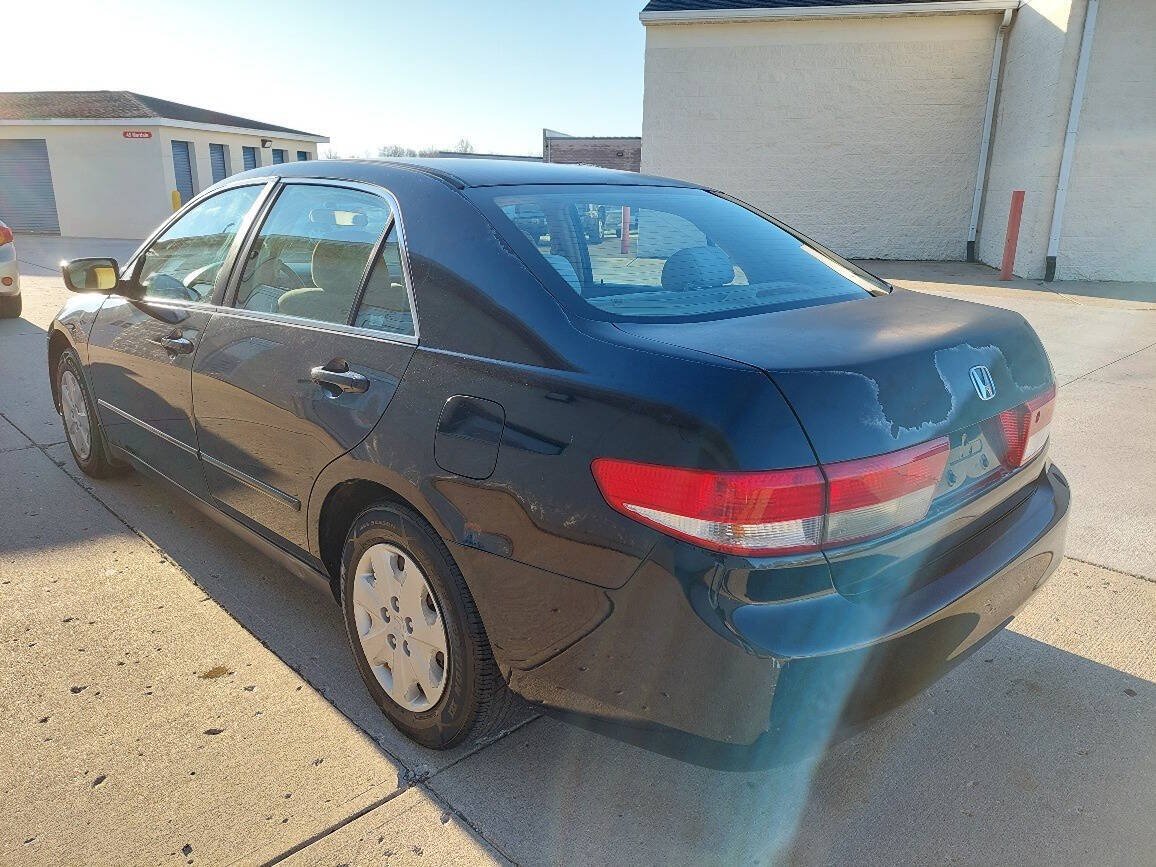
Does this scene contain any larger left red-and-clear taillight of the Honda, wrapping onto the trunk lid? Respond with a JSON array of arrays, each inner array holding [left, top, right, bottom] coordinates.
[[592, 437, 948, 556]]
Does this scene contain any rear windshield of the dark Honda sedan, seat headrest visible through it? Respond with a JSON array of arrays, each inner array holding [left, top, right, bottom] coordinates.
[[472, 185, 885, 321]]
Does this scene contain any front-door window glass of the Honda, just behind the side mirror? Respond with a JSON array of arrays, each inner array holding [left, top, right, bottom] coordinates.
[[138, 184, 265, 302]]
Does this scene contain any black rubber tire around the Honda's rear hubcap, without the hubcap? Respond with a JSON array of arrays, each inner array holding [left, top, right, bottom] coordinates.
[[341, 503, 513, 749]]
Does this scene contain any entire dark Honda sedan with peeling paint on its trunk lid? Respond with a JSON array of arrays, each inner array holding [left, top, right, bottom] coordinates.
[[47, 160, 1069, 748]]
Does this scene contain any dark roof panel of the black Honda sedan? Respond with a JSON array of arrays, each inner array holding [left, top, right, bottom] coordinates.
[[230, 157, 696, 190]]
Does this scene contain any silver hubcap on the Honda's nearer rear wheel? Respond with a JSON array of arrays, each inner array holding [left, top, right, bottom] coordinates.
[[354, 542, 450, 711]]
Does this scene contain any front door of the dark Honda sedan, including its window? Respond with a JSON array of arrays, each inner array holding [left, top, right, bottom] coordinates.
[[88, 181, 272, 496]]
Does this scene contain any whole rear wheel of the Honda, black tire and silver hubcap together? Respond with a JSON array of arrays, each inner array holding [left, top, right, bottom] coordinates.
[[341, 504, 510, 749]]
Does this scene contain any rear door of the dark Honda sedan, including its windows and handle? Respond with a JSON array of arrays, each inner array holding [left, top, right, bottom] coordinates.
[[193, 179, 417, 551]]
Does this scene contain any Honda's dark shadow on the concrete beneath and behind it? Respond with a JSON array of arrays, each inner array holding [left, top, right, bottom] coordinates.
[[33, 445, 1156, 864]]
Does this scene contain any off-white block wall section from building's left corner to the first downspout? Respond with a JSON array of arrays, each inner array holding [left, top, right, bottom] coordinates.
[[642, 14, 1000, 259]]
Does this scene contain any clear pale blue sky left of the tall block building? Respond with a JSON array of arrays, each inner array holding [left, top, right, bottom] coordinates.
[[0, 0, 645, 156]]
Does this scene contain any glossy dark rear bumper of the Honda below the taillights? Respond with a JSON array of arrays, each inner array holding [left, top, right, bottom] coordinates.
[[499, 467, 1070, 758]]
